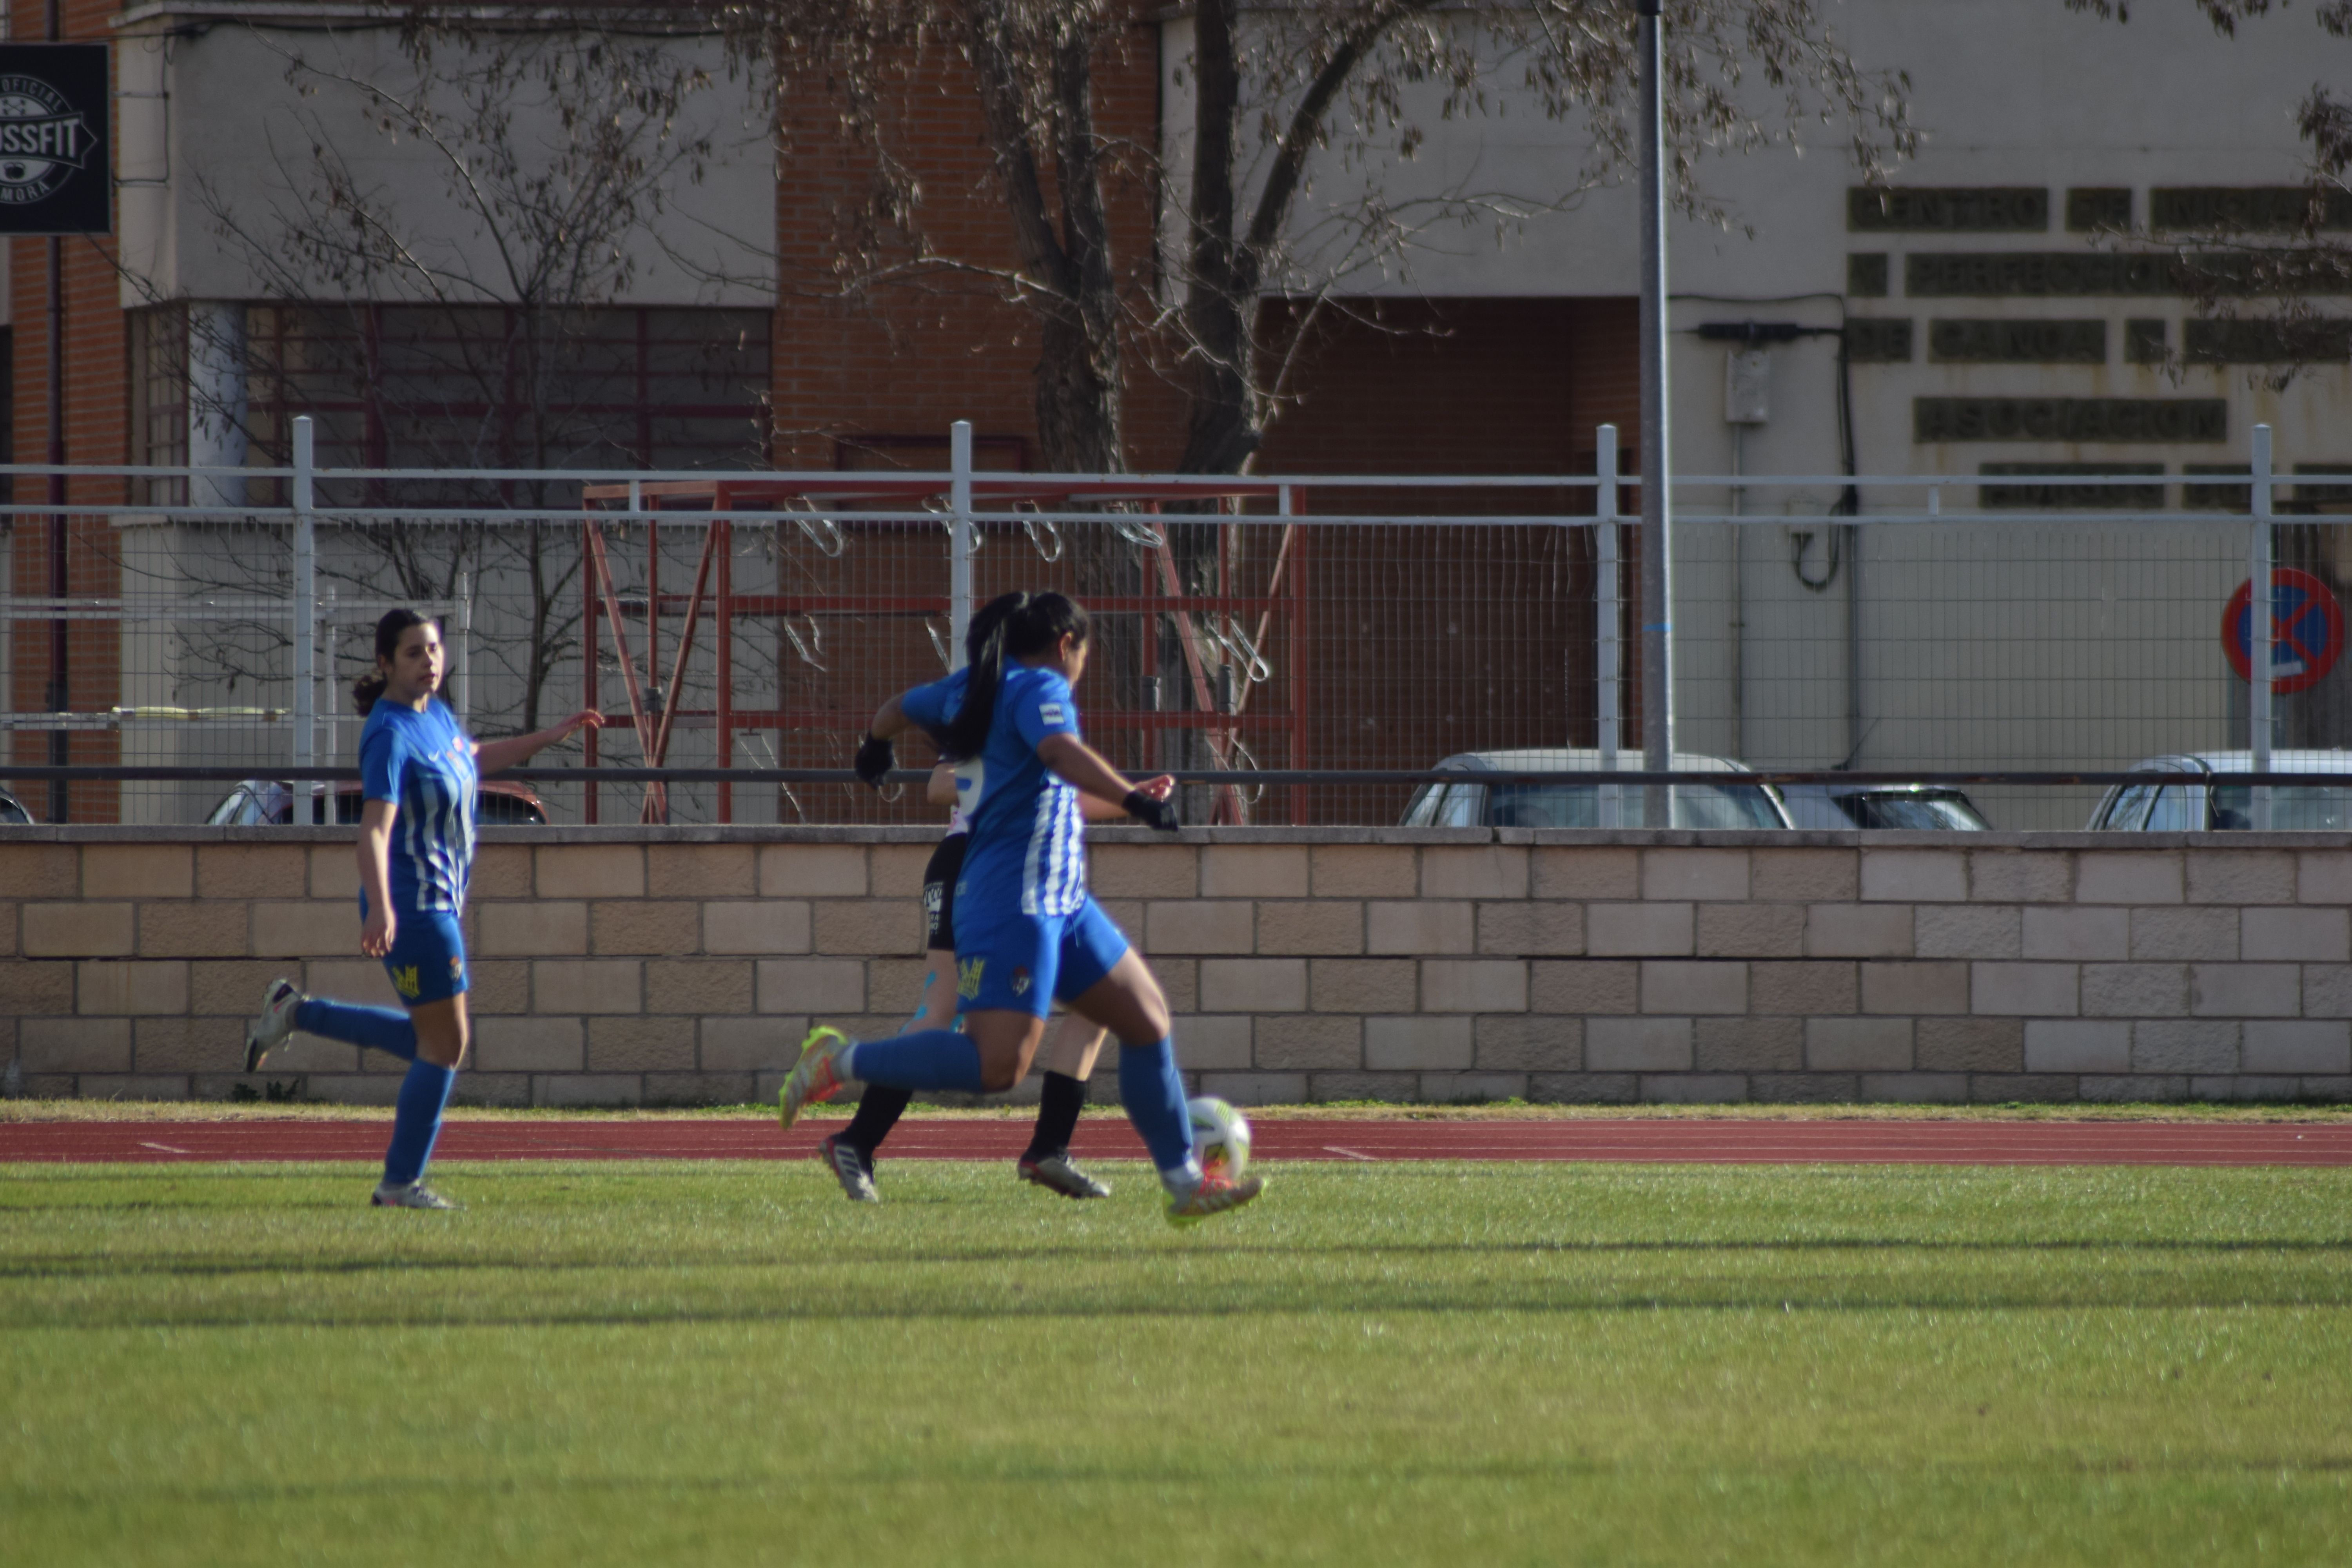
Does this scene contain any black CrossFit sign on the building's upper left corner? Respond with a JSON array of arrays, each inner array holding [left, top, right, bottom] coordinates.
[[0, 45, 115, 235]]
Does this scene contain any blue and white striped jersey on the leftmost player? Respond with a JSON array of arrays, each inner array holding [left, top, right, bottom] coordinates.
[[360, 701, 477, 915]]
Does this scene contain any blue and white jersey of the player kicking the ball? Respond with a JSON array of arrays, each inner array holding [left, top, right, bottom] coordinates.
[[898, 665, 1087, 915]]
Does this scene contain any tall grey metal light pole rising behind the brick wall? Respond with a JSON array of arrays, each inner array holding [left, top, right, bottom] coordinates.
[[1635, 0, 1675, 828]]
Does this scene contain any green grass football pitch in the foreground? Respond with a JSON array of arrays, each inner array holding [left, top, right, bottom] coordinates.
[[0, 1161, 2352, 1568]]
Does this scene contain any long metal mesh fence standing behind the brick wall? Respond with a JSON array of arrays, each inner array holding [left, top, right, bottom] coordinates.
[[0, 416, 2352, 828]]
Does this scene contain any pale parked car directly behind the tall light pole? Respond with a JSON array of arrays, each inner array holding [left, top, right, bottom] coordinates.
[[1404, 748, 1792, 828]]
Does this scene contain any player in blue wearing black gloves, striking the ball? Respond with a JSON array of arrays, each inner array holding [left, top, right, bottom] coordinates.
[[779, 592, 1263, 1225]]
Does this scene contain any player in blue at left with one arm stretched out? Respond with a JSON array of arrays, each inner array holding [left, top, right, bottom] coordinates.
[[245, 609, 604, 1208]]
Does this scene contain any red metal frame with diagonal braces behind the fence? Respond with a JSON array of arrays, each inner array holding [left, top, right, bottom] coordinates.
[[581, 470, 1308, 823]]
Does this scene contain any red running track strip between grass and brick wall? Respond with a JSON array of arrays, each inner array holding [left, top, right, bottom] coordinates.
[[0, 1117, 2352, 1166]]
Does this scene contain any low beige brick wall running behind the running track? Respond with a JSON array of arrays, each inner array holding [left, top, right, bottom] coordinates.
[[0, 828, 2352, 1105]]
